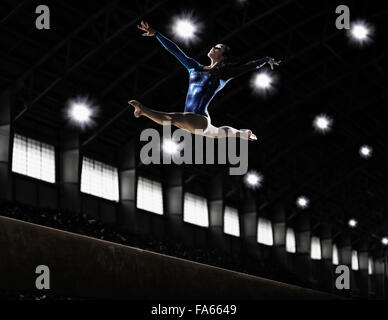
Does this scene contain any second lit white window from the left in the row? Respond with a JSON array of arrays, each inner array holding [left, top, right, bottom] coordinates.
[[81, 157, 119, 202]]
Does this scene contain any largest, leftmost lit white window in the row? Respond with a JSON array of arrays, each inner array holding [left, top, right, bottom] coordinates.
[[12, 134, 55, 183]]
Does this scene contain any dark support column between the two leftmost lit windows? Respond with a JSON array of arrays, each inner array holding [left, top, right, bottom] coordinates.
[[59, 131, 81, 213]]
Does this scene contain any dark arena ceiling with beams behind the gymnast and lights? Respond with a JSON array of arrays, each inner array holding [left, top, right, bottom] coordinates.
[[0, 0, 388, 252]]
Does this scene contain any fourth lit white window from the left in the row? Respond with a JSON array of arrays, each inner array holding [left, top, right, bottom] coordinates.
[[183, 193, 209, 227]]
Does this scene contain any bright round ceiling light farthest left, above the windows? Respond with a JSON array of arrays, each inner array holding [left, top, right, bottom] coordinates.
[[66, 97, 98, 128]]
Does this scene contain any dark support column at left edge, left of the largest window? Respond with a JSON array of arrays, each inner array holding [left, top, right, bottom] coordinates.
[[0, 89, 12, 200]]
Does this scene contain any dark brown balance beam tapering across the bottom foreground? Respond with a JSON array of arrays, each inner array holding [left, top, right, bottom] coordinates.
[[0, 216, 336, 300]]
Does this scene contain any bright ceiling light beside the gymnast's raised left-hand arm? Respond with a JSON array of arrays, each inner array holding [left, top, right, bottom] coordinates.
[[170, 13, 202, 45]]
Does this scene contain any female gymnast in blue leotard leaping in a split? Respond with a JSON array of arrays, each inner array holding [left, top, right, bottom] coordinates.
[[128, 21, 281, 141]]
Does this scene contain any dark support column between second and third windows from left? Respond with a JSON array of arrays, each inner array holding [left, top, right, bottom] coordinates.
[[117, 139, 138, 234]]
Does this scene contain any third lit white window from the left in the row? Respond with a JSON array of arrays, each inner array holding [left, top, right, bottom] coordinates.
[[136, 177, 163, 214]]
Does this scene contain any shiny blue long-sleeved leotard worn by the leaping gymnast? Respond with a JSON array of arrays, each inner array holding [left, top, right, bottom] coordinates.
[[156, 32, 269, 117]]
